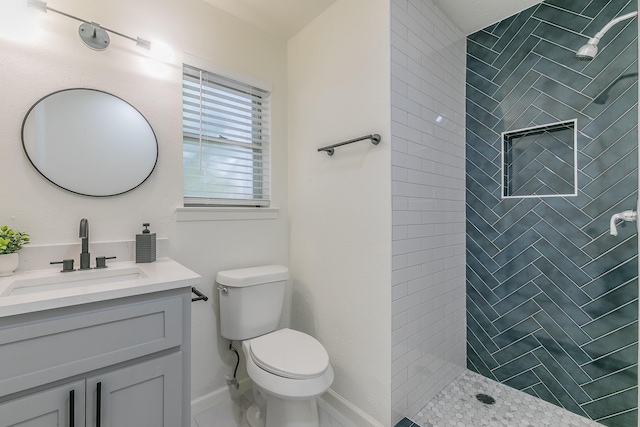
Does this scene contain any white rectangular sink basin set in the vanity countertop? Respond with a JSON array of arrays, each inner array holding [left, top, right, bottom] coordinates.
[[0, 266, 147, 297]]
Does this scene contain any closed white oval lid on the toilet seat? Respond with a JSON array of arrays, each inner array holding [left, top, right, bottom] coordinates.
[[251, 329, 329, 379]]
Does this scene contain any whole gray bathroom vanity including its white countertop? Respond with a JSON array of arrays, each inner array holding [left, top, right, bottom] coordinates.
[[0, 258, 200, 427]]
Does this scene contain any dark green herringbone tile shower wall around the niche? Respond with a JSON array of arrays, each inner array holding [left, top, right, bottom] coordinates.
[[466, 0, 638, 427]]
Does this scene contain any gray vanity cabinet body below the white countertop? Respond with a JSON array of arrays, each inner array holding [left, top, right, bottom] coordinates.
[[0, 288, 191, 427]]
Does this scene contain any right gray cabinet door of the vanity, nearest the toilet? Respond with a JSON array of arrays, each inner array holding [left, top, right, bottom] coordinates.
[[87, 352, 182, 427]]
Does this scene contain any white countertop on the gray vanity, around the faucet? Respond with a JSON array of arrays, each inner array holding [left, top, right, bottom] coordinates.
[[0, 258, 200, 318]]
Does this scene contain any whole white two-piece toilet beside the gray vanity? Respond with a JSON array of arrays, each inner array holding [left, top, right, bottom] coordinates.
[[216, 265, 333, 427]]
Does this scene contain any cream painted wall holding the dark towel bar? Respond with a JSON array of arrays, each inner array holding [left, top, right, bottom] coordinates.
[[288, 0, 391, 426]]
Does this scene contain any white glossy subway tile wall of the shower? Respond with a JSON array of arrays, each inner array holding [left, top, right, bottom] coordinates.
[[391, 0, 466, 421]]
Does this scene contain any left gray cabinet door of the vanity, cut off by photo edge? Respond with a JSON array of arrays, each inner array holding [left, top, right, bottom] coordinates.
[[0, 381, 85, 427]]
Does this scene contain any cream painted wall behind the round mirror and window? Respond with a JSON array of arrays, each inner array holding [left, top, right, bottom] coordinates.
[[0, 0, 288, 398]]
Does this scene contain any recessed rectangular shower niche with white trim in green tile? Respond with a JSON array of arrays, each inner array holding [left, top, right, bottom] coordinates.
[[502, 119, 578, 198]]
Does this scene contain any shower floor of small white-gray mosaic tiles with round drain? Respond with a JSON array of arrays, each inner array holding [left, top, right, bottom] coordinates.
[[396, 370, 603, 427]]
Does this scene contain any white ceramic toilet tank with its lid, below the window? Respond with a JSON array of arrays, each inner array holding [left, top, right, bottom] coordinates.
[[216, 265, 289, 340]]
